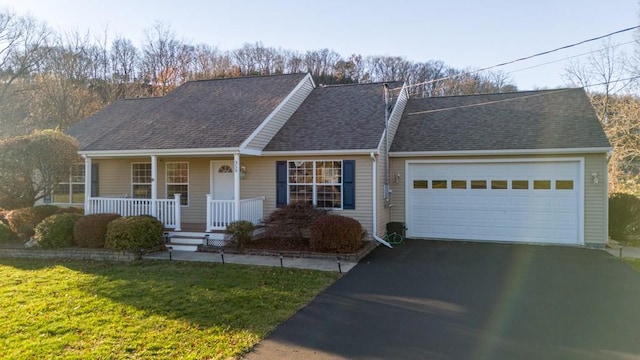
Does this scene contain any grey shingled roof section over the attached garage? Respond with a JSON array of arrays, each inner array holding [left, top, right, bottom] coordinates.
[[391, 89, 610, 152]]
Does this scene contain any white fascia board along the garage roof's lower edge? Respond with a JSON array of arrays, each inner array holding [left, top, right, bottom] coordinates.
[[389, 147, 611, 157]]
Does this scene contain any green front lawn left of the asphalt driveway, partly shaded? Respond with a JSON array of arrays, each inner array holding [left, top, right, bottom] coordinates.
[[0, 259, 339, 359]]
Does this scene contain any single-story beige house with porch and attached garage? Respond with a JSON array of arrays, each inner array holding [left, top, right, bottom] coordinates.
[[63, 74, 611, 247]]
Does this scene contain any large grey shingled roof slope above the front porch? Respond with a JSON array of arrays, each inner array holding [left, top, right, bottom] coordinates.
[[67, 74, 306, 151]]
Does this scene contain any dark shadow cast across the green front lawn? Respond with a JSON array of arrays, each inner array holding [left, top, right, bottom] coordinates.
[[62, 261, 334, 331]]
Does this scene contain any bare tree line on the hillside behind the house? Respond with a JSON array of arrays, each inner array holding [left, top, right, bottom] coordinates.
[[0, 10, 516, 138]]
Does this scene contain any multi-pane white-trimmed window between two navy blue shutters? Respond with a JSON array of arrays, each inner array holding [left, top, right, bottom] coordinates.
[[287, 160, 342, 209]]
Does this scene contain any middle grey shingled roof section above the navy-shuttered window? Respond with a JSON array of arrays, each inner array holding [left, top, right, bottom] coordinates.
[[264, 82, 402, 151]]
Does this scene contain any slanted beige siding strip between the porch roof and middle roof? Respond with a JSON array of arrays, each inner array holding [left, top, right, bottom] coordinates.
[[246, 76, 313, 151]]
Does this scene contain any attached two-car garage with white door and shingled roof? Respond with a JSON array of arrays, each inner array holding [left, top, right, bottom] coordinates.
[[389, 89, 611, 248]]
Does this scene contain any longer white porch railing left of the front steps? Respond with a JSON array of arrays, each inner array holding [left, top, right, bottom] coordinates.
[[84, 194, 180, 231]]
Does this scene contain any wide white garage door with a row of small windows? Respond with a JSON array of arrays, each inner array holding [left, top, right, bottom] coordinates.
[[406, 161, 582, 244]]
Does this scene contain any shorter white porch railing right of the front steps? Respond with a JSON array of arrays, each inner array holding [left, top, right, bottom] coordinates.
[[207, 194, 264, 231]]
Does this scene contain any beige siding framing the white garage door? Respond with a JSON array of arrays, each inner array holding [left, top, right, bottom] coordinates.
[[391, 153, 608, 247]]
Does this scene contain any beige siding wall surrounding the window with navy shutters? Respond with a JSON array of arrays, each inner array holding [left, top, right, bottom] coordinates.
[[240, 155, 373, 234]]
